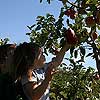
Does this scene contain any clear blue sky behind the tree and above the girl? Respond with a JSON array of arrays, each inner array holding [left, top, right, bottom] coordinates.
[[0, 0, 95, 68]]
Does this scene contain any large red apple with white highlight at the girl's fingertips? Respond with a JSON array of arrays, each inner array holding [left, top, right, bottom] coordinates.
[[65, 28, 78, 45]]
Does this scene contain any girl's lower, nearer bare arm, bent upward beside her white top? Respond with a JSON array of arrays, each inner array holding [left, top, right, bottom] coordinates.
[[23, 63, 52, 100]]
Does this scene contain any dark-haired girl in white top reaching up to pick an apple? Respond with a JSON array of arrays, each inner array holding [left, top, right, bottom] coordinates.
[[14, 42, 69, 100]]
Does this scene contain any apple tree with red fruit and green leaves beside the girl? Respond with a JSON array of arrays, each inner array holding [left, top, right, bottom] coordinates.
[[26, 0, 100, 100]]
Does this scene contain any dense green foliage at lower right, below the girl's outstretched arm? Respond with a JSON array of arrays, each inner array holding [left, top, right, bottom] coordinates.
[[50, 64, 100, 100]]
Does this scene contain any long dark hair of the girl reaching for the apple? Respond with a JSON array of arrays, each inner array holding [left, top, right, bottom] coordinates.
[[14, 42, 39, 78]]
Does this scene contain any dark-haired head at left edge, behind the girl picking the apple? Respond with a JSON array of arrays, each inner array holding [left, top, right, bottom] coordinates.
[[0, 44, 15, 73]]
